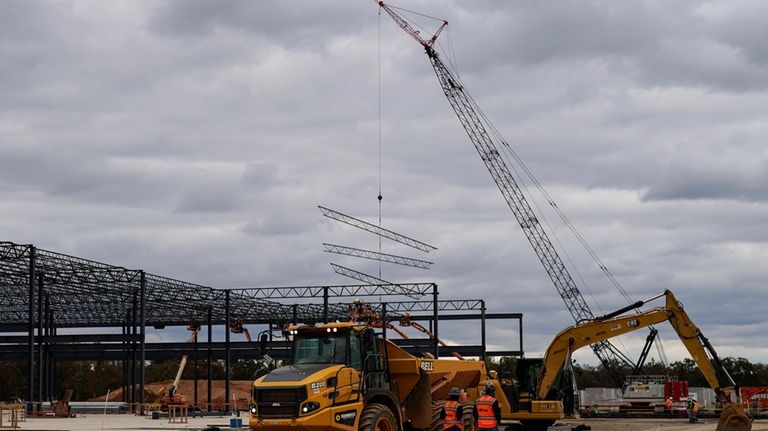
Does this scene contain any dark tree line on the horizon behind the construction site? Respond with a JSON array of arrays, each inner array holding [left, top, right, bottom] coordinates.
[[0, 357, 768, 401]]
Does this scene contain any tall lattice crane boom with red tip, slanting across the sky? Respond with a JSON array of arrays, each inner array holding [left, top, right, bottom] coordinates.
[[377, 1, 632, 374]]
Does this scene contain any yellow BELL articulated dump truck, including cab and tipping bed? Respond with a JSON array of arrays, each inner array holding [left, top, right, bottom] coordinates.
[[249, 322, 486, 431]]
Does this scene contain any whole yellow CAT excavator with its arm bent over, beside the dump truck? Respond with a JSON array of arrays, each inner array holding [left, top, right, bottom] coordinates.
[[484, 290, 752, 431]]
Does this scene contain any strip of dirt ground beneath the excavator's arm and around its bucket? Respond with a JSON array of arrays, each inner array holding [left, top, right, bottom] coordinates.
[[568, 419, 768, 431]]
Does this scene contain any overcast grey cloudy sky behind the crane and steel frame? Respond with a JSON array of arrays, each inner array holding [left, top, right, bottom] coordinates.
[[0, 0, 768, 362]]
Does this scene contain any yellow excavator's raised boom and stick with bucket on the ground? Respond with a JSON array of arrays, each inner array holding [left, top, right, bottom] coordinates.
[[537, 290, 752, 431]]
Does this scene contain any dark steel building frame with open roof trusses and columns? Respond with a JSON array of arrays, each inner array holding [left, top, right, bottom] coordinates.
[[0, 242, 523, 414]]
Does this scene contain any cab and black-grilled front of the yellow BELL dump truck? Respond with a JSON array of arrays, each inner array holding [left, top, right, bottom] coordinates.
[[250, 322, 389, 430]]
